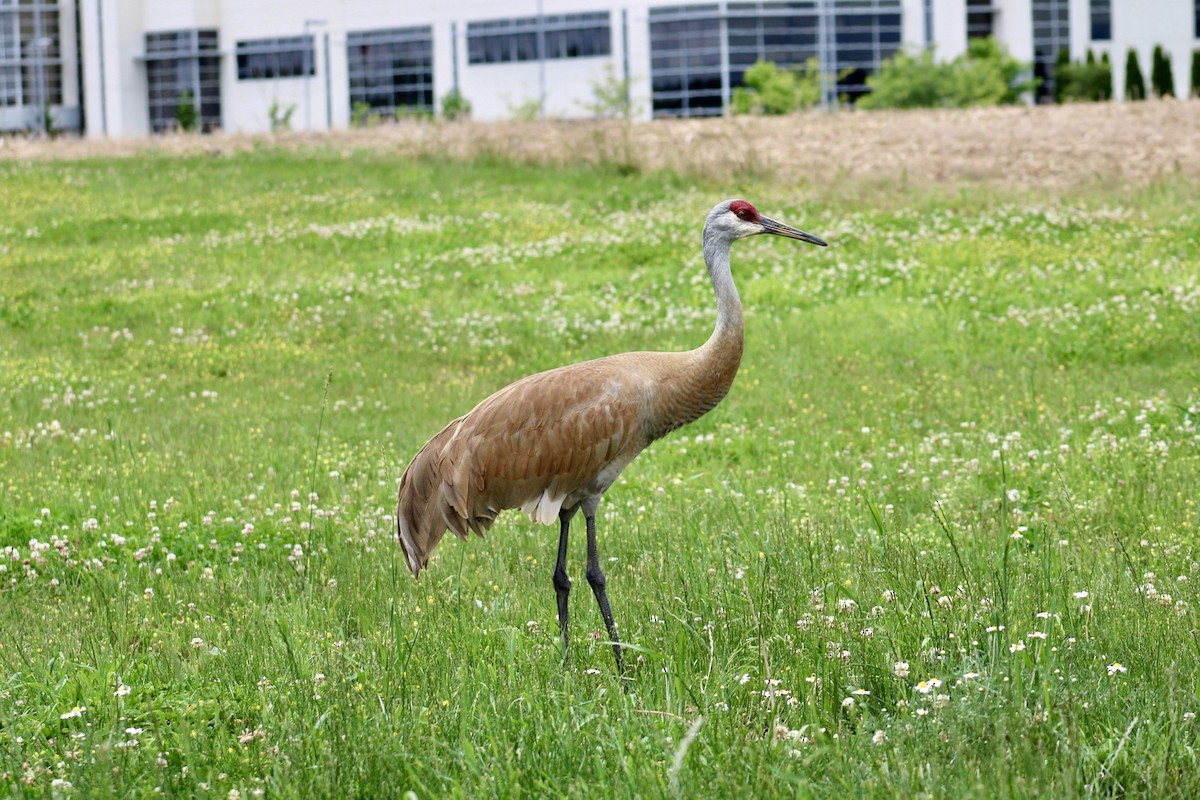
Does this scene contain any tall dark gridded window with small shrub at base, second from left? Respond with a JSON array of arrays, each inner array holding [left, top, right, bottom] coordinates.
[[142, 30, 221, 133]]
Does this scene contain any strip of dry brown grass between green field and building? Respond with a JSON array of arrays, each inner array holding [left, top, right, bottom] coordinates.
[[0, 101, 1200, 191]]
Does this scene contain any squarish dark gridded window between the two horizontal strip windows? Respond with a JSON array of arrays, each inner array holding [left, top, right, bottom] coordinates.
[[346, 26, 433, 116]]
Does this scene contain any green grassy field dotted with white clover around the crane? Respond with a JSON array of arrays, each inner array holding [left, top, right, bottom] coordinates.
[[0, 140, 1200, 798]]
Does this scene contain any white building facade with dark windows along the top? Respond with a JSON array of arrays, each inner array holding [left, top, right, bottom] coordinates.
[[0, 0, 1200, 137]]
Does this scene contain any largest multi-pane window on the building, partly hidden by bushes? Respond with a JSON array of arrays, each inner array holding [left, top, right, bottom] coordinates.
[[649, 0, 902, 116]]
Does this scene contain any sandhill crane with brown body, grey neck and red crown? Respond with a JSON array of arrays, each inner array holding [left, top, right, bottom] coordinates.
[[396, 200, 824, 674]]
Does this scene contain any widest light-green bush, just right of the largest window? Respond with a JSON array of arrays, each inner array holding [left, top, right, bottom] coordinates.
[[858, 38, 1037, 109]]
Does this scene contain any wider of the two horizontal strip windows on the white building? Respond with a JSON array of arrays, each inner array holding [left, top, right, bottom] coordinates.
[[467, 11, 612, 64]]
